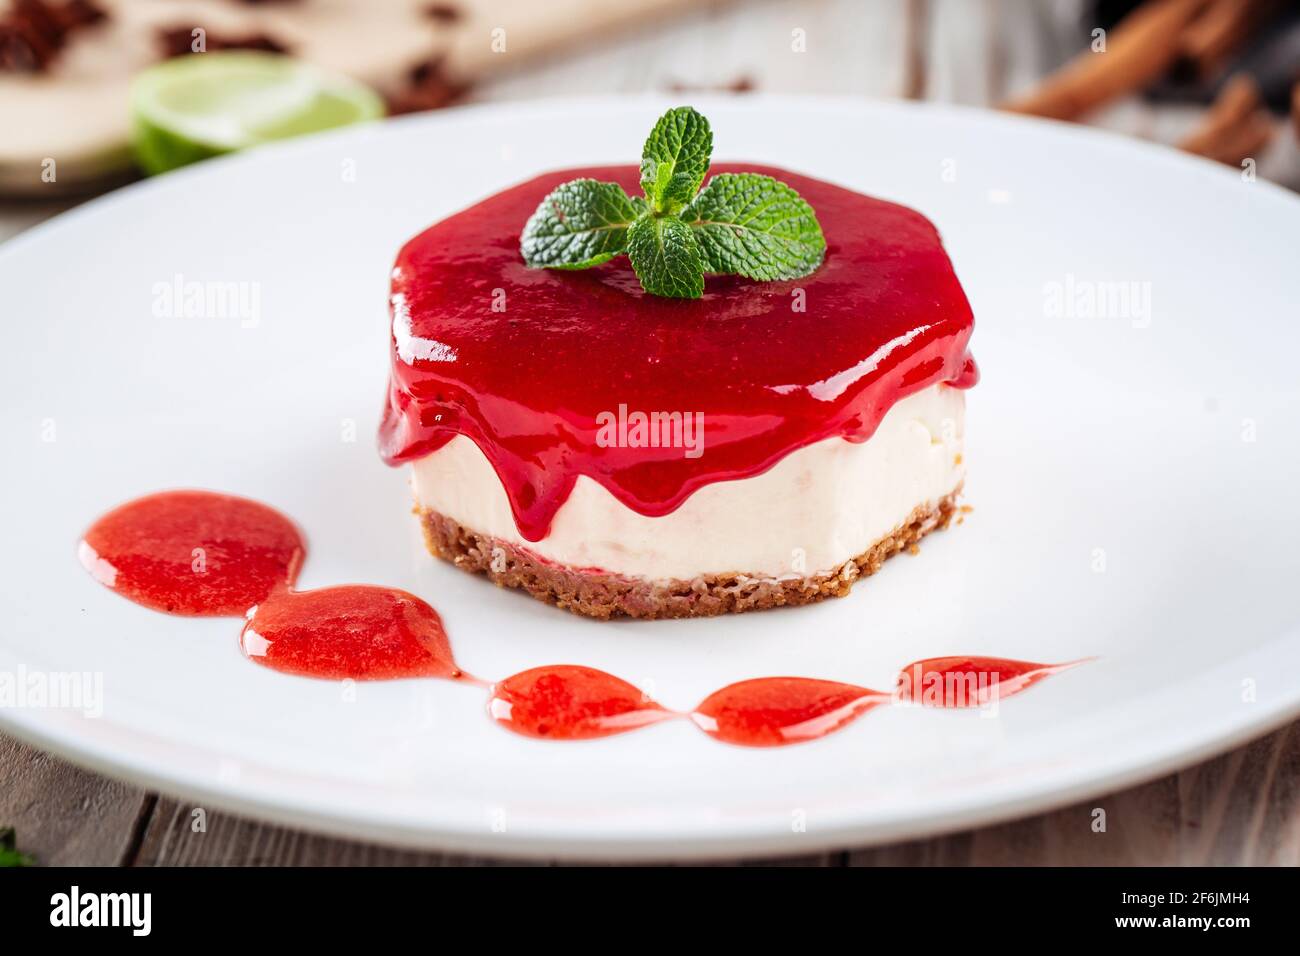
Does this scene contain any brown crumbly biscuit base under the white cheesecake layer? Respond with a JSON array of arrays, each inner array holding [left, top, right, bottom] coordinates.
[[416, 486, 961, 620]]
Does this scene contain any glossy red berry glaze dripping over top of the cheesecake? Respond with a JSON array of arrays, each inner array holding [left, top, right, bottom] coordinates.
[[380, 164, 978, 541]]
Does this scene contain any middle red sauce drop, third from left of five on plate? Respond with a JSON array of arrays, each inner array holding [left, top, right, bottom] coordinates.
[[488, 663, 675, 740]]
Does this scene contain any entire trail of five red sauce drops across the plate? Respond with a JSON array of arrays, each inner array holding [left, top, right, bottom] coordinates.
[[78, 490, 1083, 747]]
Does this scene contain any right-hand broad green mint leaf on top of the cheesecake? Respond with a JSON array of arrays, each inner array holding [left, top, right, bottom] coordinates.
[[681, 173, 826, 280]]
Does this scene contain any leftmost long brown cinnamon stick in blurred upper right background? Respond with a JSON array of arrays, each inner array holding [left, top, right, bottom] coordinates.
[[1002, 0, 1209, 120]]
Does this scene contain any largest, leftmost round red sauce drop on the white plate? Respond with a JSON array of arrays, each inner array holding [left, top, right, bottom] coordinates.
[[78, 492, 303, 617]]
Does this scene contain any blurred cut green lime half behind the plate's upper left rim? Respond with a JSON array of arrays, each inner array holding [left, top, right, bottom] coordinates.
[[131, 51, 384, 174]]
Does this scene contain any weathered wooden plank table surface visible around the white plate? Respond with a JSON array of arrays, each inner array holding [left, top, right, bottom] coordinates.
[[0, 0, 1300, 866]]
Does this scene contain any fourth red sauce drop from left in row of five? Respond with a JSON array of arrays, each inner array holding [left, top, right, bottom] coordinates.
[[690, 678, 889, 747]]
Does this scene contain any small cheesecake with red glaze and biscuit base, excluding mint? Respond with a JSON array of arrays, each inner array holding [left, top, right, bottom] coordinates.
[[380, 164, 978, 618]]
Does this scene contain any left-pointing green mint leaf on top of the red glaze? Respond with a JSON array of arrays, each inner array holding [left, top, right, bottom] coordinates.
[[519, 179, 646, 269]]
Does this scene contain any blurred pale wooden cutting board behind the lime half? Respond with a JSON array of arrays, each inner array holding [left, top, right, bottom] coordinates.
[[0, 0, 699, 195]]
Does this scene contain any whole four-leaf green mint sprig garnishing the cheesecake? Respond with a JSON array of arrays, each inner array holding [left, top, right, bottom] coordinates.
[[519, 107, 826, 299]]
